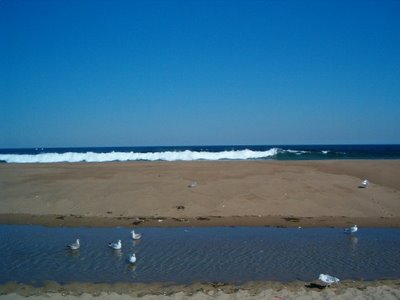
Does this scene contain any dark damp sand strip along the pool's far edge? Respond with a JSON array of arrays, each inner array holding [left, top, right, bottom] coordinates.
[[0, 214, 400, 228]]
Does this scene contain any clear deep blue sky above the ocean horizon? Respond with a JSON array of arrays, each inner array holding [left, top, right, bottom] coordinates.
[[0, 0, 400, 148]]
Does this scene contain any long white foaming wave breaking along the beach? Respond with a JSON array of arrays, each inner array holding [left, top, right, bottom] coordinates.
[[0, 148, 278, 163]]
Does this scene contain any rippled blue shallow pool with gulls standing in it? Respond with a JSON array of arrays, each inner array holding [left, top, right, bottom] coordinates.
[[0, 225, 400, 285]]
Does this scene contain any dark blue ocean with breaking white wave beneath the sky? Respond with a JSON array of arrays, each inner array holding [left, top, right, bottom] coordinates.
[[0, 144, 400, 163]]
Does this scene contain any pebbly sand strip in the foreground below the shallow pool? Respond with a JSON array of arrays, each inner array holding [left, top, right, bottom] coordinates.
[[0, 279, 400, 299]]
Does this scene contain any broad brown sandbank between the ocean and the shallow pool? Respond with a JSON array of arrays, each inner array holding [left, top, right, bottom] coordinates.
[[0, 160, 400, 227]]
